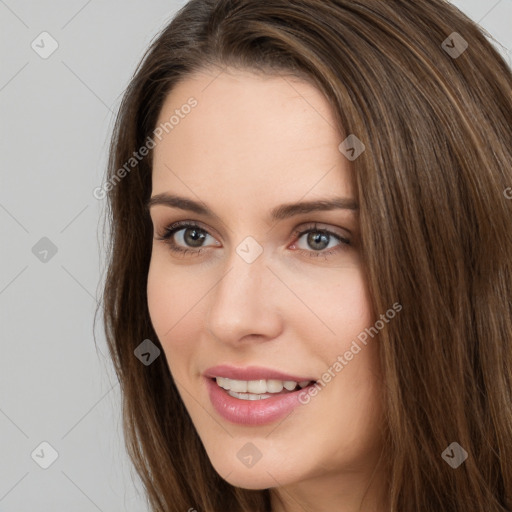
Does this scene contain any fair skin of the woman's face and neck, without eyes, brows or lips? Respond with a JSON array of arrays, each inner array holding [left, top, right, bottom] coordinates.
[[147, 69, 385, 512]]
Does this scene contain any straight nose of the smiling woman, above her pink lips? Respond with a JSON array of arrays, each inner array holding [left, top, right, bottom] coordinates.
[[205, 246, 283, 346]]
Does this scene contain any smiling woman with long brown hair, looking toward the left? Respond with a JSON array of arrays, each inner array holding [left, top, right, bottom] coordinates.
[[100, 0, 512, 512]]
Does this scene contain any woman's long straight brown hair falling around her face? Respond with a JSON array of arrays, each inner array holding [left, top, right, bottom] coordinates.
[[97, 0, 512, 512]]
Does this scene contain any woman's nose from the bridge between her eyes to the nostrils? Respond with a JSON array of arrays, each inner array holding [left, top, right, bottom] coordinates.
[[206, 239, 278, 341]]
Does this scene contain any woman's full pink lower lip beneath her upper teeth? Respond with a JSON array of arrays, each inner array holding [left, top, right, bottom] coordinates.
[[206, 378, 313, 425]]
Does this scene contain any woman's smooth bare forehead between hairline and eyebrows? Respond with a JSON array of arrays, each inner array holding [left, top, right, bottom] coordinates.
[[153, 70, 353, 206]]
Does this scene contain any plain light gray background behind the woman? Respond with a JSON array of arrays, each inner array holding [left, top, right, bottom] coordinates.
[[0, 0, 512, 512]]
